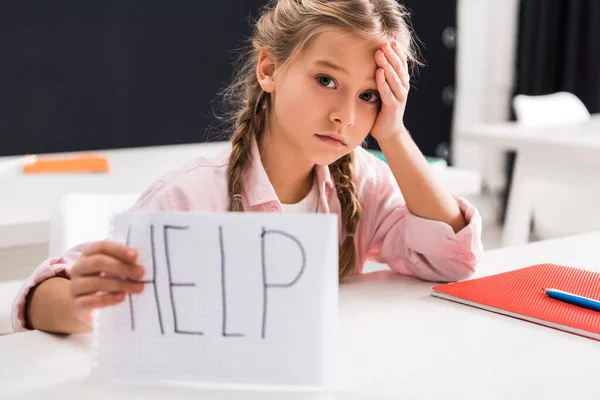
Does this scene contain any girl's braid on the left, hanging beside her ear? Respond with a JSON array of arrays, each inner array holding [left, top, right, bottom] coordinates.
[[227, 80, 268, 212]]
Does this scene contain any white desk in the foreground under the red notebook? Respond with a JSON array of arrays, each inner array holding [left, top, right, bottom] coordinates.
[[0, 232, 600, 400]]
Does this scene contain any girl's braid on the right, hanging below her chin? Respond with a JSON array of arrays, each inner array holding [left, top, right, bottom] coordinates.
[[329, 151, 362, 279]]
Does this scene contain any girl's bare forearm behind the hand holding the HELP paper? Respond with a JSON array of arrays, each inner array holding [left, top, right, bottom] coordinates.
[[26, 277, 90, 333]]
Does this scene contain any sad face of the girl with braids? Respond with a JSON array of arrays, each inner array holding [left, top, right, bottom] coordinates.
[[259, 29, 381, 165]]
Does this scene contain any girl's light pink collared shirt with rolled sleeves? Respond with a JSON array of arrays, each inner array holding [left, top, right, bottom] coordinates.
[[12, 142, 483, 332]]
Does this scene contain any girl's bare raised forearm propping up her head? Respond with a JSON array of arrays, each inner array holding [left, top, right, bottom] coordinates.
[[378, 130, 467, 232]]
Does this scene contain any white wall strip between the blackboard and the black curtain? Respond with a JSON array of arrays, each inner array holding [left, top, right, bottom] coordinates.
[[452, 0, 519, 192]]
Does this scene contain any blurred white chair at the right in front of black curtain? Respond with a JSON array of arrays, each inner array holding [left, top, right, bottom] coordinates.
[[513, 92, 600, 239]]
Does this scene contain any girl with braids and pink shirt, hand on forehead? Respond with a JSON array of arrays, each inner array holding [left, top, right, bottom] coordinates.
[[13, 0, 482, 333]]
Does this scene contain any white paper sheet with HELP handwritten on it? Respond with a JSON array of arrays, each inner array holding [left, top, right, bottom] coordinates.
[[92, 212, 338, 387]]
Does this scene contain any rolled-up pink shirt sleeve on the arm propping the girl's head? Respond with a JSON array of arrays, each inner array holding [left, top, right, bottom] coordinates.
[[368, 158, 483, 282]]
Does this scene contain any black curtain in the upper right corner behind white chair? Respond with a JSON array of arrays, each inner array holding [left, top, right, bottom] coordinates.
[[503, 0, 600, 217]]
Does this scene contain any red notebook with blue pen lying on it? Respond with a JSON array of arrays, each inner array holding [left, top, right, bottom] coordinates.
[[431, 264, 600, 340]]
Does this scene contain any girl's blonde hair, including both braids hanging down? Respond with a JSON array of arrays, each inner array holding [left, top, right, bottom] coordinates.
[[221, 0, 418, 278]]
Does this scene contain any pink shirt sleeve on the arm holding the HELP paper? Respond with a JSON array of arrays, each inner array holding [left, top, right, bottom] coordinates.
[[11, 181, 171, 332]]
